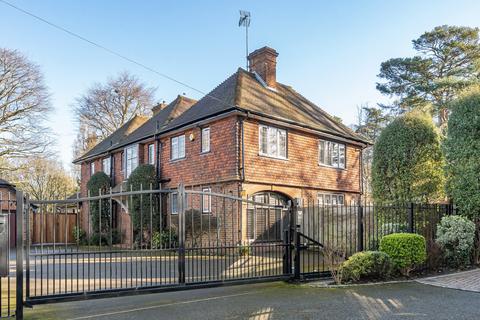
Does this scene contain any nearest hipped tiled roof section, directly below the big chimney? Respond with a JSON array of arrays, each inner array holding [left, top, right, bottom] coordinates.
[[162, 68, 367, 142]]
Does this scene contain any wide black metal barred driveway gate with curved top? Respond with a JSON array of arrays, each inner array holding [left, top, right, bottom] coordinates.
[[21, 186, 292, 304]]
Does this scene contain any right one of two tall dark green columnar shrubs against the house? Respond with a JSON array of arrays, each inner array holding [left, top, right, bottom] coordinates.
[[127, 164, 160, 244]]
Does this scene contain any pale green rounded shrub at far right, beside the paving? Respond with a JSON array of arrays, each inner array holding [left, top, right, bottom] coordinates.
[[436, 216, 475, 267]]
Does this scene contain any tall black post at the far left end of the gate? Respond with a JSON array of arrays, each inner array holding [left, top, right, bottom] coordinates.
[[15, 190, 24, 320]]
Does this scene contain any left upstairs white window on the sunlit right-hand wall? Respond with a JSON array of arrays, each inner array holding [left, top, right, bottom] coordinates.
[[258, 125, 287, 159]]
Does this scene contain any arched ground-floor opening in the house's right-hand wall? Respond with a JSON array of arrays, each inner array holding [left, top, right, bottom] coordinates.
[[246, 191, 290, 242]]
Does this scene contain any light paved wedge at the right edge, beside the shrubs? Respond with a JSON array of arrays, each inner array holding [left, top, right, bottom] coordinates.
[[417, 268, 480, 292]]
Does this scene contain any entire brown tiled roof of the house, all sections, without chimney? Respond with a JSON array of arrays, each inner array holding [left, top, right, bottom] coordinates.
[[75, 68, 369, 162]]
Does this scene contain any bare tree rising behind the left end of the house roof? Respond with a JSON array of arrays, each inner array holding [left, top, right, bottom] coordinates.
[[75, 72, 154, 139]]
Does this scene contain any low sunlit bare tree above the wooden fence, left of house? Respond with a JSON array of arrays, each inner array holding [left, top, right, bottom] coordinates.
[[12, 157, 77, 200]]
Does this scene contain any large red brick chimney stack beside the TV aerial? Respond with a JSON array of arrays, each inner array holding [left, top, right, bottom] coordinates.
[[248, 47, 278, 88]]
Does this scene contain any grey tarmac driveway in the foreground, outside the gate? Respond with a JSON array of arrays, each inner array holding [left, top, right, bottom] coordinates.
[[26, 282, 480, 320]]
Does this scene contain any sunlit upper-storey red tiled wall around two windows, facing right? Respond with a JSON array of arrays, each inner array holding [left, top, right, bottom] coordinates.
[[244, 120, 360, 192]]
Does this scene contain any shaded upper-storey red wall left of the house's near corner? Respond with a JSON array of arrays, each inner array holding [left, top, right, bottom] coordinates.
[[160, 116, 239, 188]]
